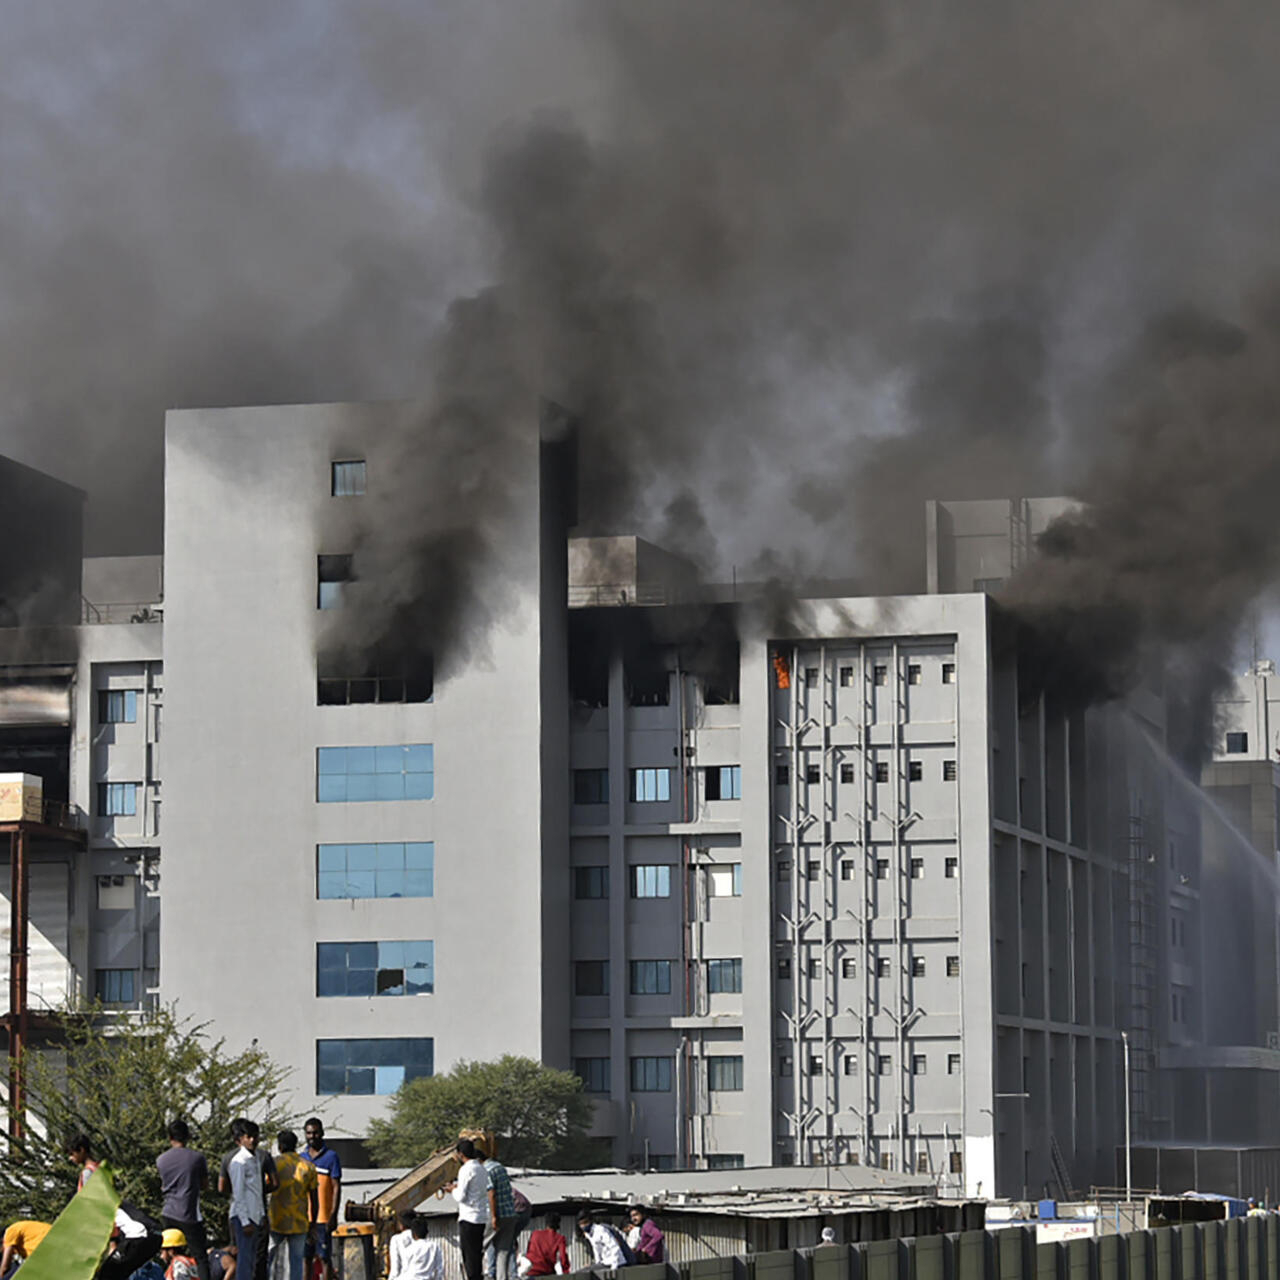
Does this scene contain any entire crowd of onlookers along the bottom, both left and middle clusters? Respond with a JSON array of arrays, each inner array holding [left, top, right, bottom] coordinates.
[[0, 1131, 666, 1280]]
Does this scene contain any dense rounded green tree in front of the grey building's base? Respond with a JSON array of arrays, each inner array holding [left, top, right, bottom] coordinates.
[[369, 1053, 591, 1169]]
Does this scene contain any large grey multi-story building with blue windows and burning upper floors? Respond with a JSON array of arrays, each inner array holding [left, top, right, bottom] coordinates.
[[0, 430, 1239, 1194]]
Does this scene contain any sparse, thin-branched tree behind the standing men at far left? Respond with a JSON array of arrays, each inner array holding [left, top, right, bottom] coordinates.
[[0, 1007, 291, 1228]]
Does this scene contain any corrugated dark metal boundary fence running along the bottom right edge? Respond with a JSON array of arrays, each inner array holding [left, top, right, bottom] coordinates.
[[560, 1213, 1280, 1280]]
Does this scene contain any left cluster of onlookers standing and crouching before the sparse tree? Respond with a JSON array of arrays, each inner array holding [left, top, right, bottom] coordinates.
[[0, 1116, 342, 1280]]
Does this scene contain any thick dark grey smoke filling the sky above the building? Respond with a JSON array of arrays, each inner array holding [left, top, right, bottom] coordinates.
[[0, 0, 1280, 701]]
